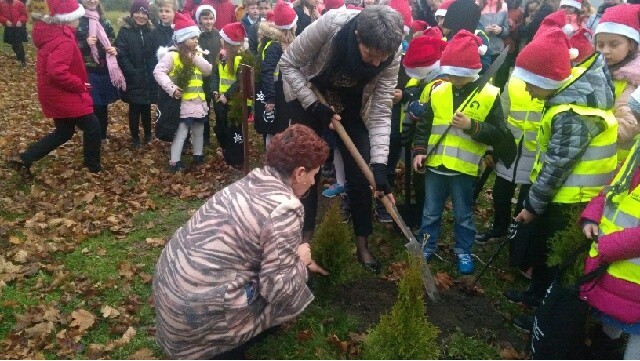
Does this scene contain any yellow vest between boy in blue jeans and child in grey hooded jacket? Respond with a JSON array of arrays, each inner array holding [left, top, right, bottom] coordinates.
[[495, 77, 544, 184]]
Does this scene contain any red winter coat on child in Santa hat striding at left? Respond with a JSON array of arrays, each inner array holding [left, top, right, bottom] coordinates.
[[32, 21, 93, 118]]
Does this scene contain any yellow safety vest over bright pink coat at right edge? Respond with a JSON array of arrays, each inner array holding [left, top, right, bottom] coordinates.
[[589, 142, 640, 284]]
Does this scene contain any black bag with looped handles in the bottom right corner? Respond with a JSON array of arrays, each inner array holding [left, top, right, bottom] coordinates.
[[530, 245, 609, 360]]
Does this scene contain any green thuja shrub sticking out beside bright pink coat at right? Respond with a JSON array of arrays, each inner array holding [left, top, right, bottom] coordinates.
[[547, 205, 591, 285]]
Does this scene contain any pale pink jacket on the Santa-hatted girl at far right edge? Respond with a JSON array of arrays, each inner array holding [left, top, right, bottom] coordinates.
[[612, 53, 640, 148]]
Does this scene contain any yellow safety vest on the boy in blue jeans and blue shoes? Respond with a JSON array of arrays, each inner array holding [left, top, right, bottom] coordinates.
[[427, 82, 500, 176]]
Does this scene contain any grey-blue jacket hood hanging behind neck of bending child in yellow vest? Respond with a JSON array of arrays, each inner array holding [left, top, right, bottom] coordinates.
[[545, 53, 615, 110]]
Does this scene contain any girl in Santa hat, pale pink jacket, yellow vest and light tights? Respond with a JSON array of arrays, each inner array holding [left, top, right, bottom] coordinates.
[[153, 13, 213, 173]]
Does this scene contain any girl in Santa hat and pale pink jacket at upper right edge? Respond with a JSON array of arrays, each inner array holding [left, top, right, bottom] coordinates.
[[595, 4, 640, 163]]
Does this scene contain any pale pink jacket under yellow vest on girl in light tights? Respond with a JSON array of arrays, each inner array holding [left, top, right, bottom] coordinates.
[[153, 51, 213, 118]]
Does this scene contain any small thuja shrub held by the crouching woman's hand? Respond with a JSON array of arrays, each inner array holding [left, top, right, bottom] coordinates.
[[311, 202, 362, 290]]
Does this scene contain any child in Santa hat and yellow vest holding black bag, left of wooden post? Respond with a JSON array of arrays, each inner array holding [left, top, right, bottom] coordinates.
[[211, 23, 246, 168]]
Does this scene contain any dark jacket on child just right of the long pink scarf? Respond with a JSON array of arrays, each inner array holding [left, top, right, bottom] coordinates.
[[116, 16, 158, 104]]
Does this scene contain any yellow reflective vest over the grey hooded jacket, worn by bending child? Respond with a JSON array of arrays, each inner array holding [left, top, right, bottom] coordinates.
[[531, 104, 618, 203]]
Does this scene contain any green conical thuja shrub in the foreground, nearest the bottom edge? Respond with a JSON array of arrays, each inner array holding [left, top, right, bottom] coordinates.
[[362, 255, 440, 360]]
